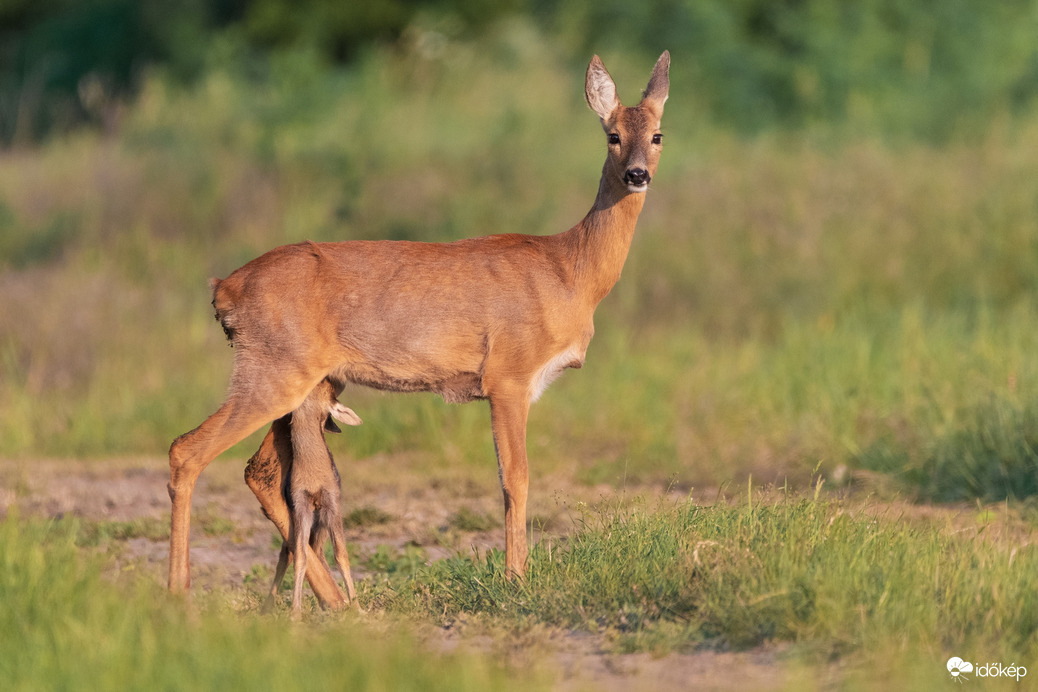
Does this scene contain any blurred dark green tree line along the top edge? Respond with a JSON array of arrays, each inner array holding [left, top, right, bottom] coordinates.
[[0, 0, 1038, 144]]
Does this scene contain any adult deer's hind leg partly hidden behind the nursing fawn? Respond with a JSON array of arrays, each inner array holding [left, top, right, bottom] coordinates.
[[245, 414, 349, 610]]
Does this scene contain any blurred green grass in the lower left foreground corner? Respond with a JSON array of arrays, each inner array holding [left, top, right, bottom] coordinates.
[[0, 518, 538, 691]]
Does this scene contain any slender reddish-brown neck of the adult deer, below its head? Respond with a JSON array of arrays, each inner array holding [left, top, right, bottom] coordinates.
[[570, 164, 646, 306]]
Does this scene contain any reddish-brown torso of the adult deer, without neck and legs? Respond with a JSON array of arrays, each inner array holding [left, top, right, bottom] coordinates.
[[214, 234, 593, 402]]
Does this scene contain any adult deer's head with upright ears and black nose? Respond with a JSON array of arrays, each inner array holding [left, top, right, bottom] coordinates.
[[584, 51, 671, 192]]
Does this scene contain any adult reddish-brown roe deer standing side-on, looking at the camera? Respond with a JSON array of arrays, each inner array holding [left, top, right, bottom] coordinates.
[[169, 52, 671, 591]]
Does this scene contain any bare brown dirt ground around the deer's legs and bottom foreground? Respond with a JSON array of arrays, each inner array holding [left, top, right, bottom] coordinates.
[[0, 459, 793, 692]]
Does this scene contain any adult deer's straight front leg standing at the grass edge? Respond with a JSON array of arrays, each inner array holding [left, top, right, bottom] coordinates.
[[490, 393, 529, 577]]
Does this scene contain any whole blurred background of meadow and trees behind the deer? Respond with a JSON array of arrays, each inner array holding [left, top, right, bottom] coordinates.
[[0, 0, 1038, 500]]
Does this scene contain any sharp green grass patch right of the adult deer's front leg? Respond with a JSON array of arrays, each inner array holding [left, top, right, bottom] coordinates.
[[371, 492, 1038, 670]]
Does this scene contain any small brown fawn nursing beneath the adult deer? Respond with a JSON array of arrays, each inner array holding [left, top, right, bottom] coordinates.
[[268, 380, 360, 618]]
